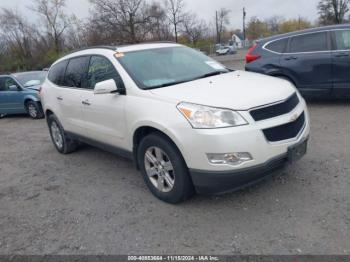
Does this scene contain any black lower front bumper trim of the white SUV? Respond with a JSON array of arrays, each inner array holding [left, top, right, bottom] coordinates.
[[190, 154, 288, 195]]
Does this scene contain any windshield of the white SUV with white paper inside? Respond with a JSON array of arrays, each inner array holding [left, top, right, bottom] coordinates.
[[118, 47, 229, 89]]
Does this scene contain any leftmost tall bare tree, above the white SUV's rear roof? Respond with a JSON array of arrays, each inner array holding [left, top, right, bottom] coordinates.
[[32, 0, 70, 53]]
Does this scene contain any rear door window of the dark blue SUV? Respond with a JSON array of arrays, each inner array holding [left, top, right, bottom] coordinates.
[[289, 32, 328, 53]]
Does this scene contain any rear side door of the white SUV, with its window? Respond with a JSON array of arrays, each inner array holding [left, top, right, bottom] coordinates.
[[57, 56, 90, 136]]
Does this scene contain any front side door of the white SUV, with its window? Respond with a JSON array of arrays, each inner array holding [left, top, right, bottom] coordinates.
[[82, 55, 126, 147]]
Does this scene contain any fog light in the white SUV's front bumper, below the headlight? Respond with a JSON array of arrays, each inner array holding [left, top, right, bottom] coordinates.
[[207, 152, 253, 166]]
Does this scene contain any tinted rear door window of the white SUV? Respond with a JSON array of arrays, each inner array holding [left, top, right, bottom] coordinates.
[[63, 56, 90, 88]]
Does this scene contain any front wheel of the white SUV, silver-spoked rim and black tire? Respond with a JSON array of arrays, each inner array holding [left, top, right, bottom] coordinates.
[[137, 133, 195, 204]]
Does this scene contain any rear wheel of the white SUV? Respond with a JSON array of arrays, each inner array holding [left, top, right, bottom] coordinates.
[[47, 115, 79, 154]]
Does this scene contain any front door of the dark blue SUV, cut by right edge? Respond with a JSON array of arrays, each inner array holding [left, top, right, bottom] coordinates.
[[332, 29, 350, 97]]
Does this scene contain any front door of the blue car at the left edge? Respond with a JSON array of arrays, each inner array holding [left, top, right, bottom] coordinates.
[[0, 76, 25, 114]]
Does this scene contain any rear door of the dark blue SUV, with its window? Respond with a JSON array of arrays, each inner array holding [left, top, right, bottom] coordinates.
[[281, 32, 332, 96]]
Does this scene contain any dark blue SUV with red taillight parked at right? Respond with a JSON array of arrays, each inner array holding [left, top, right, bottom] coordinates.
[[246, 25, 350, 98]]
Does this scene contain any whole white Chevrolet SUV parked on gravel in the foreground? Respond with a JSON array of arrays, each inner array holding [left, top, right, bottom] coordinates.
[[41, 43, 310, 203]]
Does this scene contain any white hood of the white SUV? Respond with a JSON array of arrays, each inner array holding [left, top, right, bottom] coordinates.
[[151, 71, 296, 111]]
